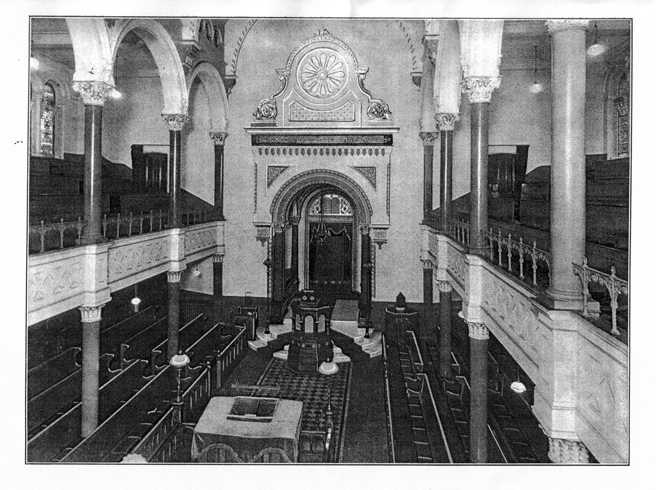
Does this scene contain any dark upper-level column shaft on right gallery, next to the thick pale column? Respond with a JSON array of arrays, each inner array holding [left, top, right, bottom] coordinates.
[[469, 102, 490, 253]]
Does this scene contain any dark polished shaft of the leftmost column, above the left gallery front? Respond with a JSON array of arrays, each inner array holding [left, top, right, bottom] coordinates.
[[82, 105, 103, 244]]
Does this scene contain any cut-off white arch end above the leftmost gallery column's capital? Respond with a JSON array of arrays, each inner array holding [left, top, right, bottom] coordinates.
[[66, 18, 114, 86]]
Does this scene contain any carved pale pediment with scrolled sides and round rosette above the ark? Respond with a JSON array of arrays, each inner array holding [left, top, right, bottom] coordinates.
[[253, 29, 391, 128]]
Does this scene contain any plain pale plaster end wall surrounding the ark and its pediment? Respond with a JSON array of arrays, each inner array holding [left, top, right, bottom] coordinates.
[[224, 19, 423, 301]]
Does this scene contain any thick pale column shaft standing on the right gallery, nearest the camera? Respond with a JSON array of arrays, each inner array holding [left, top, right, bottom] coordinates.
[[549, 27, 586, 309]]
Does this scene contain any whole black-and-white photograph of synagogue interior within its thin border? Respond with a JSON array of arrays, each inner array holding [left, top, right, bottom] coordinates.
[[24, 17, 633, 465]]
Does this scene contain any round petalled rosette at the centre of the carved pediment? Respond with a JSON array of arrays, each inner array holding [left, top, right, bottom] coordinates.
[[299, 51, 346, 99]]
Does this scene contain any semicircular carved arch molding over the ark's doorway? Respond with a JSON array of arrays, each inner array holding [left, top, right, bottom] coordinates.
[[271, 169, 373, 225]]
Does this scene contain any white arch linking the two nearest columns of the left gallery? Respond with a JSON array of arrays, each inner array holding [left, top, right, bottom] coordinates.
[[110, 19, 189, 115]]
